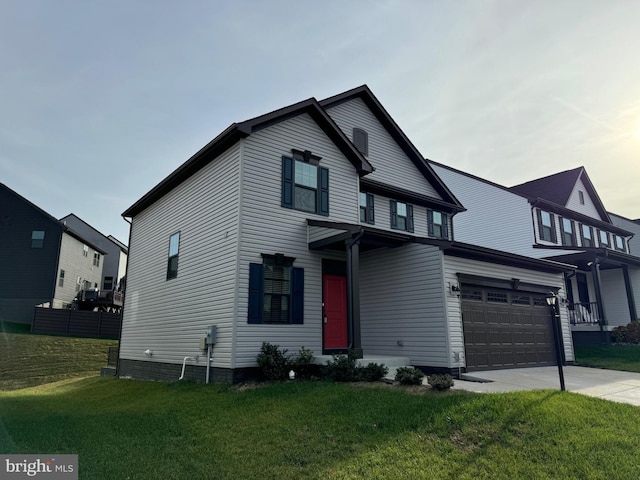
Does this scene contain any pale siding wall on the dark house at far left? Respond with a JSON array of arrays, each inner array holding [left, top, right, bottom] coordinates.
[[53, 233, 104, 308]]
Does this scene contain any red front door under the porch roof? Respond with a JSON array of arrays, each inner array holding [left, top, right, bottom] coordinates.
[[322, 275, 348, 349]]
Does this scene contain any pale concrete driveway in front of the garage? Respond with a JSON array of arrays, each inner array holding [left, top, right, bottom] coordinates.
[[453, 366, 640, 406]]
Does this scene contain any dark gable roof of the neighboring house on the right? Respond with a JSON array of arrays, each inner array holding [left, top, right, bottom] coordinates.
[[510, 167, 611, 223]]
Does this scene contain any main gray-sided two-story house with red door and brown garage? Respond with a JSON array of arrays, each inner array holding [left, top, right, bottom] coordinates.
[[118, 86, 573, 381]]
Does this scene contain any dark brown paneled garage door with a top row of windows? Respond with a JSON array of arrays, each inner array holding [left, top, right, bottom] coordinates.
[[461, 285, 555, 371]]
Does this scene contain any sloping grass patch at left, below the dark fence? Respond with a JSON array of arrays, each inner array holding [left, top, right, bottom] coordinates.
[[0, 332, 118, 391]]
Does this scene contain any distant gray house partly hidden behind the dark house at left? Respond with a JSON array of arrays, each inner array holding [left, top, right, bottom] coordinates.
[[60, 213, 128, 290]]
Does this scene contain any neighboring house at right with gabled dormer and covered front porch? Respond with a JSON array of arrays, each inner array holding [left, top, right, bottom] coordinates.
[[430, 162, 640, 342]]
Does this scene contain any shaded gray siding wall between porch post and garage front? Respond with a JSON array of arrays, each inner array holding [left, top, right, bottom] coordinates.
[[360, 244, 450, 367]]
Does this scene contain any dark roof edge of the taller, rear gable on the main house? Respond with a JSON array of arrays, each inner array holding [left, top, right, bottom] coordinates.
[[320, 85, 465, 211]]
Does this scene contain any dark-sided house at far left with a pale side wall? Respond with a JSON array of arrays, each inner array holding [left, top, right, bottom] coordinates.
[[0, 184, 105, 323]]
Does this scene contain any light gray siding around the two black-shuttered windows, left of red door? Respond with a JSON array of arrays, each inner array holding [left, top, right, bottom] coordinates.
[[235, 114, 359, 368]]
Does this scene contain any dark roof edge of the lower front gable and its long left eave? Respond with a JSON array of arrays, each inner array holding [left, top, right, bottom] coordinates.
[[122, 98, 373, 217]]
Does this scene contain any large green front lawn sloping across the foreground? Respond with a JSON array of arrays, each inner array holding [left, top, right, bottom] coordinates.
[[0, 377, 640, 480]]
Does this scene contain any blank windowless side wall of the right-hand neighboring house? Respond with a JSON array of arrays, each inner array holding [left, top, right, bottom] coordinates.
[[432, 164, 535, 256]]
